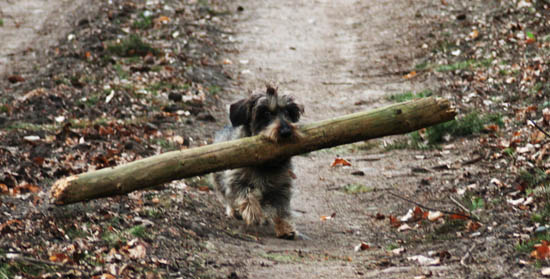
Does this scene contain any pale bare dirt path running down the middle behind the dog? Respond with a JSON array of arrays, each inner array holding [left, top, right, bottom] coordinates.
[[217, 0, 458, 278]]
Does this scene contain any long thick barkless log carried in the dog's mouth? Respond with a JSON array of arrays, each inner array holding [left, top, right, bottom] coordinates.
[[50, 97, 456, 205]]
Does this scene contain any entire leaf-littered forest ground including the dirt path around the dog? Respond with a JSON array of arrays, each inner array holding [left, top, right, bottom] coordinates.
[[0, 0, 550, 278]]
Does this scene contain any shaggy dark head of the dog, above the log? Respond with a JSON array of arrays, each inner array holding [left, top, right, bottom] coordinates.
[[229, 85, 304, 142]]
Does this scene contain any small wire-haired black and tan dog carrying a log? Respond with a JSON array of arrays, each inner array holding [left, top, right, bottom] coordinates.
[[214, 85, 304, 239]]
